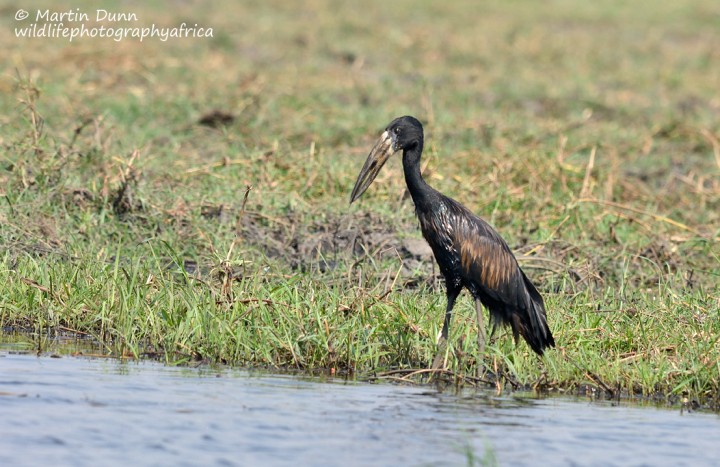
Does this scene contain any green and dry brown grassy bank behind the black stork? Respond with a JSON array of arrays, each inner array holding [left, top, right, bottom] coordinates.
[[0, 0, 720, 406]]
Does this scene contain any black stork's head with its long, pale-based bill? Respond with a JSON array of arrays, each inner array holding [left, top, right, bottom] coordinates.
[[350, 115, 423, 203]]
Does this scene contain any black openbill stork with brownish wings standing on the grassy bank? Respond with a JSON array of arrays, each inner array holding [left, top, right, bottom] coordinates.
[[350, 116, 555, 355]]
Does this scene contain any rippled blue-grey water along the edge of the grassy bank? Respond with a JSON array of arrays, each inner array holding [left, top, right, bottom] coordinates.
[[0, 351, 720, 466]]
